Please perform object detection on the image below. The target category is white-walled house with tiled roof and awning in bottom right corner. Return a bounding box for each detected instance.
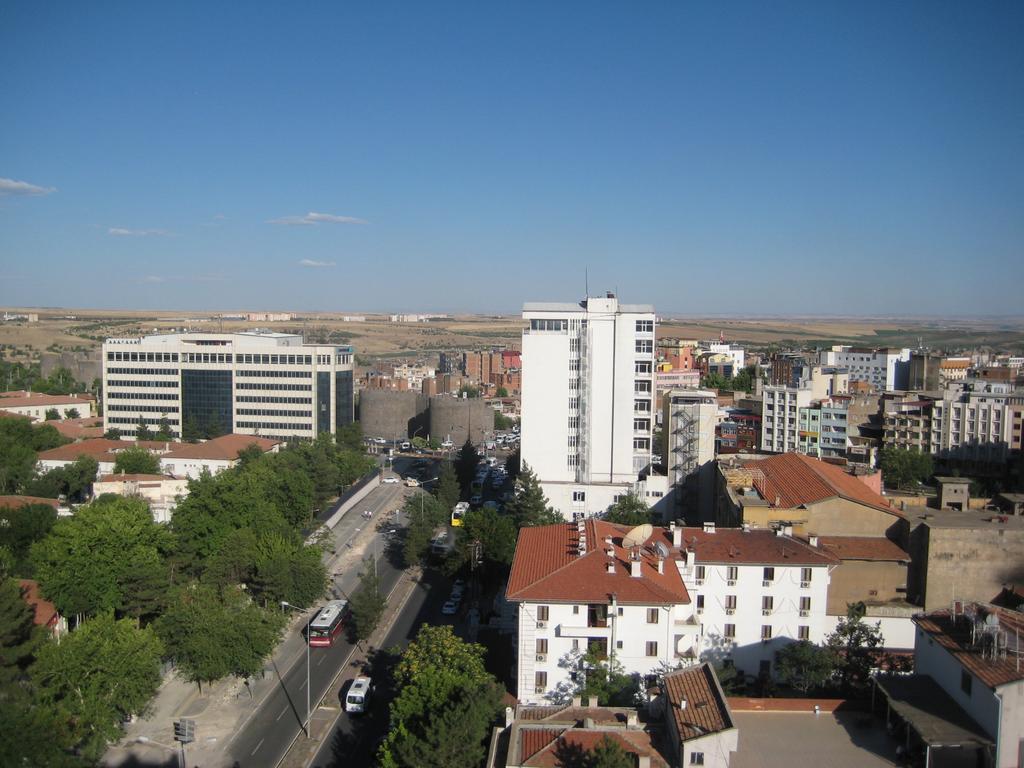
[877,601,1024,768]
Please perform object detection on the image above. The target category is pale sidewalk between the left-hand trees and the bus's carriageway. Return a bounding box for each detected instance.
[100,486,408,768]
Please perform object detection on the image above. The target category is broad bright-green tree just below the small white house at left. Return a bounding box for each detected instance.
[31,496,172,615]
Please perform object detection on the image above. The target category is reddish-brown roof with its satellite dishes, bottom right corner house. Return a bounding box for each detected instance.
[913,603,1024,688]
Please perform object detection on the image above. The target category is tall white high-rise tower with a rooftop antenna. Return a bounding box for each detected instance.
[521,294,655,519]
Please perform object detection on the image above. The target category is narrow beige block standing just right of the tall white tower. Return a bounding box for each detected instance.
[662,389,718,521]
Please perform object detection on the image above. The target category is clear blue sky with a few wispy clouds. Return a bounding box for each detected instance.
[0,0,1024,315]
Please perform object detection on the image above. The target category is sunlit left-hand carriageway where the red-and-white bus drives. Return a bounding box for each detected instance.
[227,485,402,766]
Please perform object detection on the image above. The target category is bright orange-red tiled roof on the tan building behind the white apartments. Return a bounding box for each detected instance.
[743,453,902,517]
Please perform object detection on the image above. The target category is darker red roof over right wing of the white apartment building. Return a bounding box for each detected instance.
[667,528,836,565]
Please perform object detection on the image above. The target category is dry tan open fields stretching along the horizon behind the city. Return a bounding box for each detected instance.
[0,307,1024,359]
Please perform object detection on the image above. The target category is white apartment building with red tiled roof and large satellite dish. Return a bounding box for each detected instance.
[506,519,839,703]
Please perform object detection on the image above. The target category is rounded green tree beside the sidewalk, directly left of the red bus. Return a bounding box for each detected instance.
[155,584,286,687]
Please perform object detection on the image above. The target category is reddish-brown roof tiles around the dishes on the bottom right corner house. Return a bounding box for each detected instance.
[913,603,1024,688]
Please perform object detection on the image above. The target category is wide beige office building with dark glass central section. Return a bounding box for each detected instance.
[103,333,353,439]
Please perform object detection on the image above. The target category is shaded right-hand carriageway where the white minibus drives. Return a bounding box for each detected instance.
[311,568,466,768]
